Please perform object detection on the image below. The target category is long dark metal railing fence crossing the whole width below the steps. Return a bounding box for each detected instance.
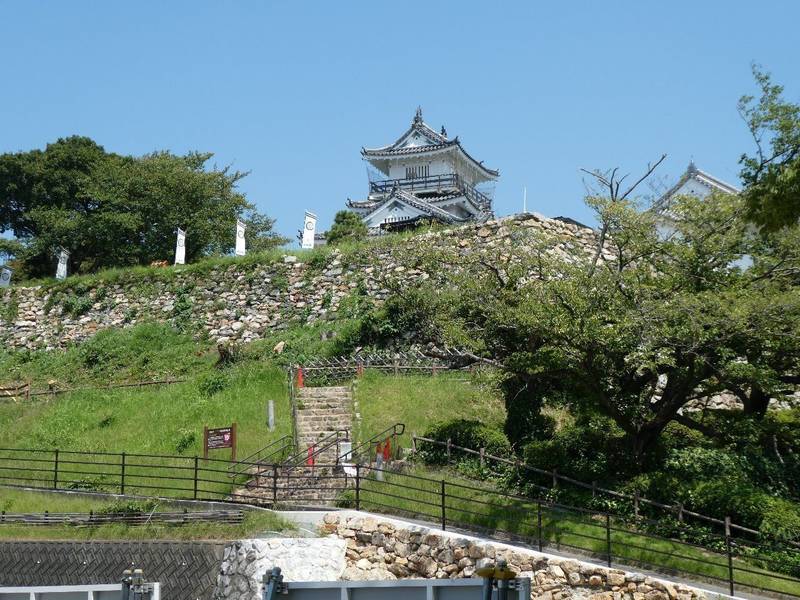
[0,448,800,598]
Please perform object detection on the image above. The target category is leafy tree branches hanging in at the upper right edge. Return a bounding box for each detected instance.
[739,66,800,231]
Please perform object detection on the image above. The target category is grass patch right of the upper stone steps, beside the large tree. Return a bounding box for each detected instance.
[355,370,505,443]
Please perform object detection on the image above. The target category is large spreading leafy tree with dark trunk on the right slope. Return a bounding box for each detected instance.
[382,196,800,468]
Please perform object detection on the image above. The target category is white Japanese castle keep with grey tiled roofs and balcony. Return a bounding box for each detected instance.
[347,108,500,235]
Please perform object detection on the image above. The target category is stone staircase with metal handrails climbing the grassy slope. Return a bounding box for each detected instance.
[230,386,352,506]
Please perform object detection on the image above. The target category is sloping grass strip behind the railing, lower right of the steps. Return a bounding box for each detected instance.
[351,468,800,594]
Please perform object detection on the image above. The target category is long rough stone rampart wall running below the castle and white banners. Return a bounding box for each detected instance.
[0,214,594,349]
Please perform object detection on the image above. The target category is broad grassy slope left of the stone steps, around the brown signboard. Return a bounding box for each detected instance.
[0,324,292,499]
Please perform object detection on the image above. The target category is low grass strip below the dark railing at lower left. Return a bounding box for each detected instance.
[0,488,294,540]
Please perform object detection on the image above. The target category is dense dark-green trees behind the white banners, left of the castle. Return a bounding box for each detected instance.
[0,136,285,276]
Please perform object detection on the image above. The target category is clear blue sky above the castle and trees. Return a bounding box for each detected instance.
[0,0,800,241]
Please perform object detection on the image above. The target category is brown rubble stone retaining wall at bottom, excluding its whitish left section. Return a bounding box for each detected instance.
[322,511,707,600]
